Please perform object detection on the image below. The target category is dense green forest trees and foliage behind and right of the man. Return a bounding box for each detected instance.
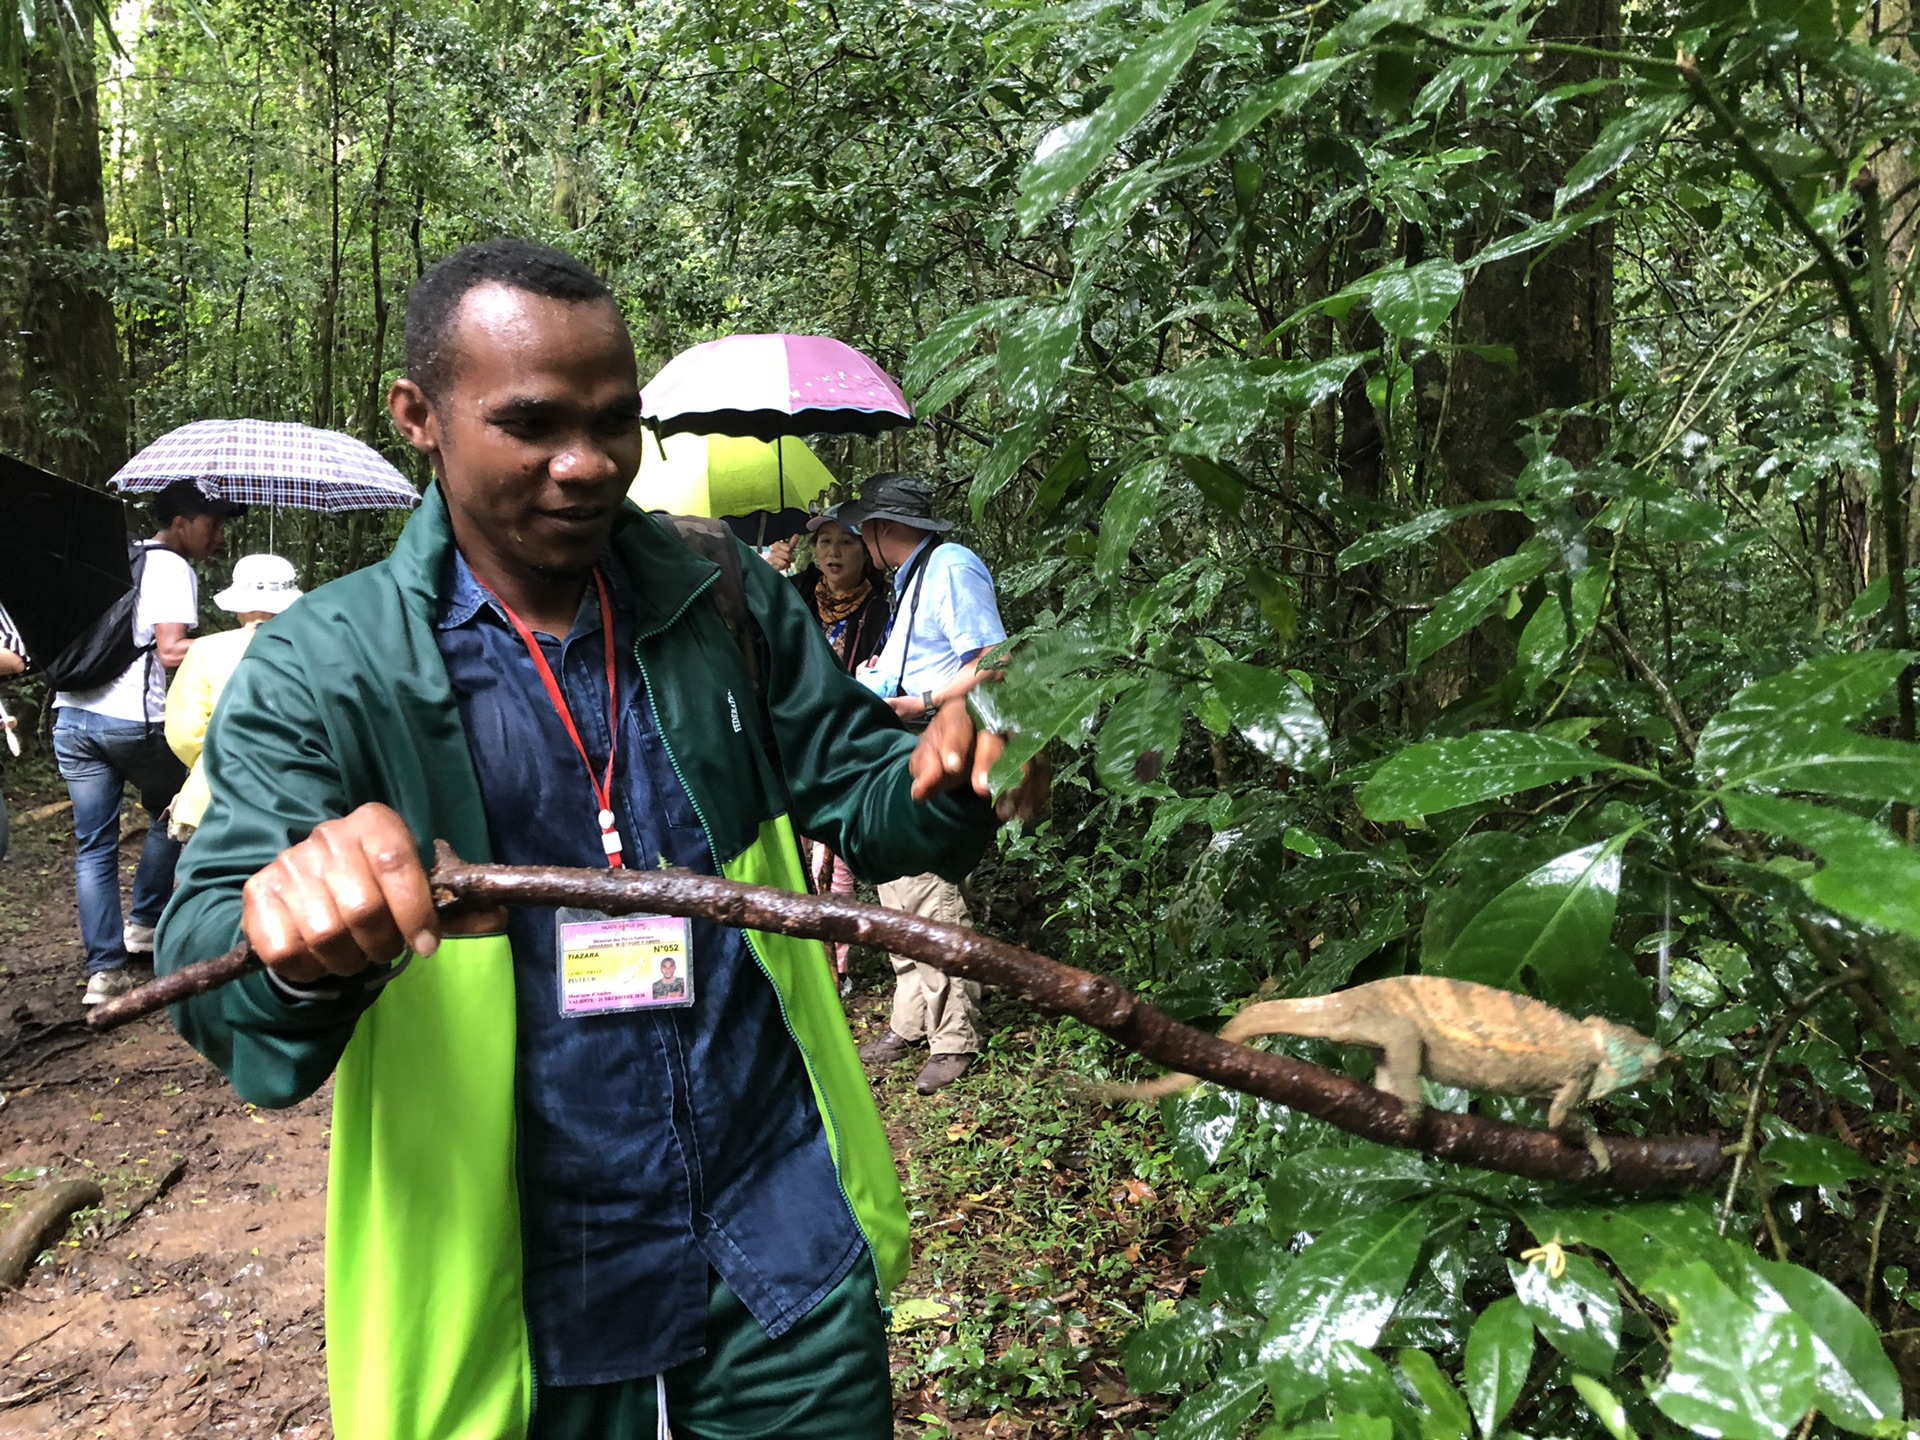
[0,0,1920,1440]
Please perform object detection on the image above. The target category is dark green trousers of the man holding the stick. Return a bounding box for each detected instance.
[530,1258,893,1440]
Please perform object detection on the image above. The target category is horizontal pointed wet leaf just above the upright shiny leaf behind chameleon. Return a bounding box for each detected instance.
[1359,730,1617,822]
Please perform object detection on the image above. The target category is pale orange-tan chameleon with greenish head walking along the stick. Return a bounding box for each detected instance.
[1104,975,1668,1169]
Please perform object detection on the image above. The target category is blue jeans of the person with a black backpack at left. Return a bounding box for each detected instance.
[54,705,186,975]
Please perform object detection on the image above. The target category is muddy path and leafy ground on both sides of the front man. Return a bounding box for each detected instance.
[0,762,1194,1440]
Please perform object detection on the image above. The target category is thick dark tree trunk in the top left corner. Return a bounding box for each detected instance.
[0,0,127,484]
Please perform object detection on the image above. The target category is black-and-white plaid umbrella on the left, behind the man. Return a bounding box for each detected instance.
[113,420,420,515]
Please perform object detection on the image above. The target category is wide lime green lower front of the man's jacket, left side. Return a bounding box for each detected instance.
[326,935,534,1440]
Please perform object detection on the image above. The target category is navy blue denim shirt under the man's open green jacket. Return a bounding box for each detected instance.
[436,555,866,1384]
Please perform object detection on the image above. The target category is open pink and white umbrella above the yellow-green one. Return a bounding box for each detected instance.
[641,334,914,440]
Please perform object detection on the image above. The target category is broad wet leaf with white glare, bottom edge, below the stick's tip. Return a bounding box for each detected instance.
[1645,1260,1818,1440]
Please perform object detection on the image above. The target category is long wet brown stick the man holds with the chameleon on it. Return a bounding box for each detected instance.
[88,843,1726,1190]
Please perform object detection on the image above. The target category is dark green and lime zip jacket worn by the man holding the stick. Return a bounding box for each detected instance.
[157,486,995,1440]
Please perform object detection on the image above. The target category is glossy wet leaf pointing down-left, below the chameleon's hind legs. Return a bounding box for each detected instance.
[1260,1204,1427,1388]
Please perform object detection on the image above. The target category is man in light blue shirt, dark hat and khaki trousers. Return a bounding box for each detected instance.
[843,472,1006,1094]
